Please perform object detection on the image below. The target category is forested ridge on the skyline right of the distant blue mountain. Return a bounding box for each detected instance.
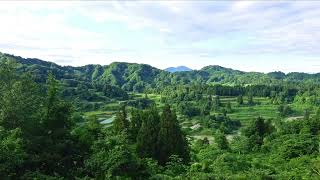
[175,66,320,85]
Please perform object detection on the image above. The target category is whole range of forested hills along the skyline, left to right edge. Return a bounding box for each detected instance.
[0,53,320,92]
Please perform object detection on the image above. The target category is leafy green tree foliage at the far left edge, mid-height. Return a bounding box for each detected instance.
[0,61,40,131]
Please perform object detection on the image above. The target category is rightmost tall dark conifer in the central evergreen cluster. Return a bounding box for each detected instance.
[157,105,189,164]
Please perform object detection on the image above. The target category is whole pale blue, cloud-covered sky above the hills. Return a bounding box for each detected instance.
[0,0,320,73]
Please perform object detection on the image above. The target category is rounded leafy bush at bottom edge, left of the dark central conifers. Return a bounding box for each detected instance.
[85,135,146,179]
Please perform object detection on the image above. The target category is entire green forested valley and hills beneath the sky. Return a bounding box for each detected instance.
[0,53,320,180]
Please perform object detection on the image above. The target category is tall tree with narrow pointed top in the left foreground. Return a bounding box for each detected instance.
[29,74,77,176]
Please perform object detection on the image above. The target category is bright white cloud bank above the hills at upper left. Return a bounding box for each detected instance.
[0,2,125,65]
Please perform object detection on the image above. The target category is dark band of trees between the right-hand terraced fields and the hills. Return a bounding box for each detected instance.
[159,84,298,102]
